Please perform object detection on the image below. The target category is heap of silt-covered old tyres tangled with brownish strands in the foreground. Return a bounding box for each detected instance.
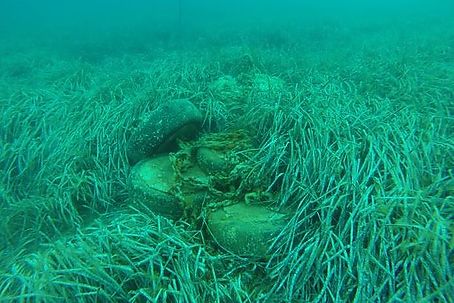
[129,100,287,258]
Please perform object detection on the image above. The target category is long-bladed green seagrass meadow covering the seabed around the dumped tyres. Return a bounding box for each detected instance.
[0,1,454,303]
